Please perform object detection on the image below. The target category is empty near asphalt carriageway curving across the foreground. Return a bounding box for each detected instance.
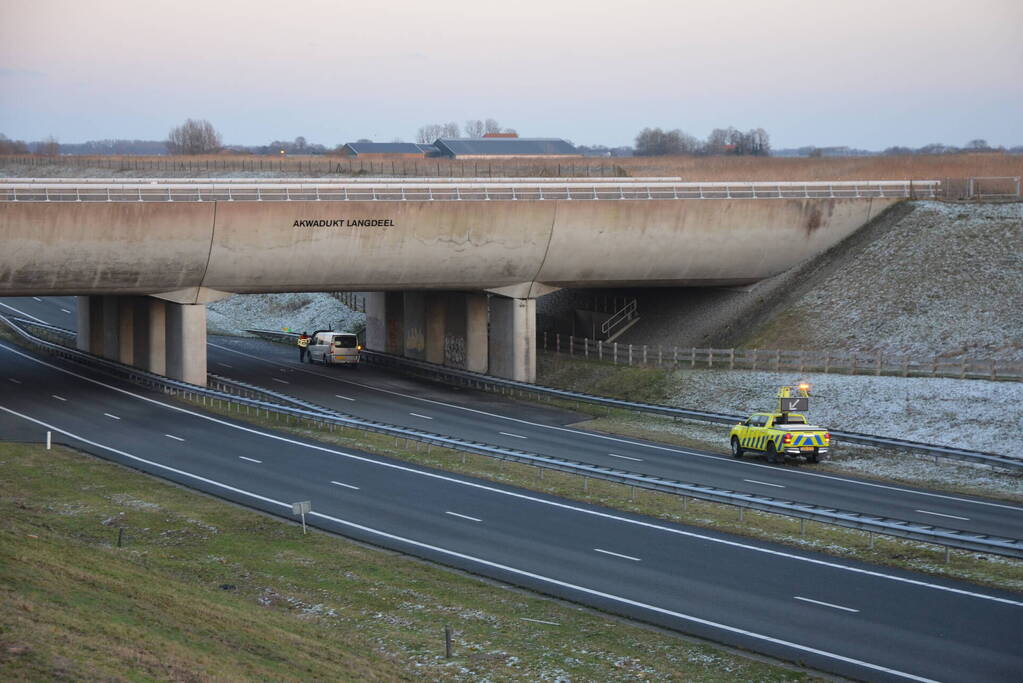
[0,342,1023,681]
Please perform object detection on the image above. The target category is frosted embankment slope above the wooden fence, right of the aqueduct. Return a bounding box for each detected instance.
[746,201,1023,360]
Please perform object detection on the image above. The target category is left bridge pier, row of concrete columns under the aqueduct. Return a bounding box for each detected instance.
[76,295,207,386]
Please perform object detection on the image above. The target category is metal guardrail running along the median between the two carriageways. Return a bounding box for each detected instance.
[0,315,1023,558]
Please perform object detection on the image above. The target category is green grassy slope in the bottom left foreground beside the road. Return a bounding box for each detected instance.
[0,444,807,681]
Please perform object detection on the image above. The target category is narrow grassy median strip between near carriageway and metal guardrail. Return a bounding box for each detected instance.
[175,394,1023,591]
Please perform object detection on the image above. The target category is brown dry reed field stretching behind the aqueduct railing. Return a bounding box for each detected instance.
[0,152,1023,181]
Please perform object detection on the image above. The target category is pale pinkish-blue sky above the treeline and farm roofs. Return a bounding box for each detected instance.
[0,0,1023,149]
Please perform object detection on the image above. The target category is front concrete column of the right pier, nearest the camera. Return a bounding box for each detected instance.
[490,297,536,381]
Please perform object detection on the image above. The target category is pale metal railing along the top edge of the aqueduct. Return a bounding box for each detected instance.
[0,180,941,202]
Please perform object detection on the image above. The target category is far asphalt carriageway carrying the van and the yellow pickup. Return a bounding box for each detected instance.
[6,298,1023,538]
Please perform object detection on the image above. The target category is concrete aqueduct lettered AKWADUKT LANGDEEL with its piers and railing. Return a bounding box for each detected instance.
[0,178,938,383]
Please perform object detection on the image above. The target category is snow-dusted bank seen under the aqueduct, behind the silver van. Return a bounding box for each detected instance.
[207,292,366,335]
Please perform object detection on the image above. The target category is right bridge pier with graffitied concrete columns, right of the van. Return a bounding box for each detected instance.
[366,291,536,381]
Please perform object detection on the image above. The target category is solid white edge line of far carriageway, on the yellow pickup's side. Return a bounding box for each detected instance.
[203,341,1023,512]
